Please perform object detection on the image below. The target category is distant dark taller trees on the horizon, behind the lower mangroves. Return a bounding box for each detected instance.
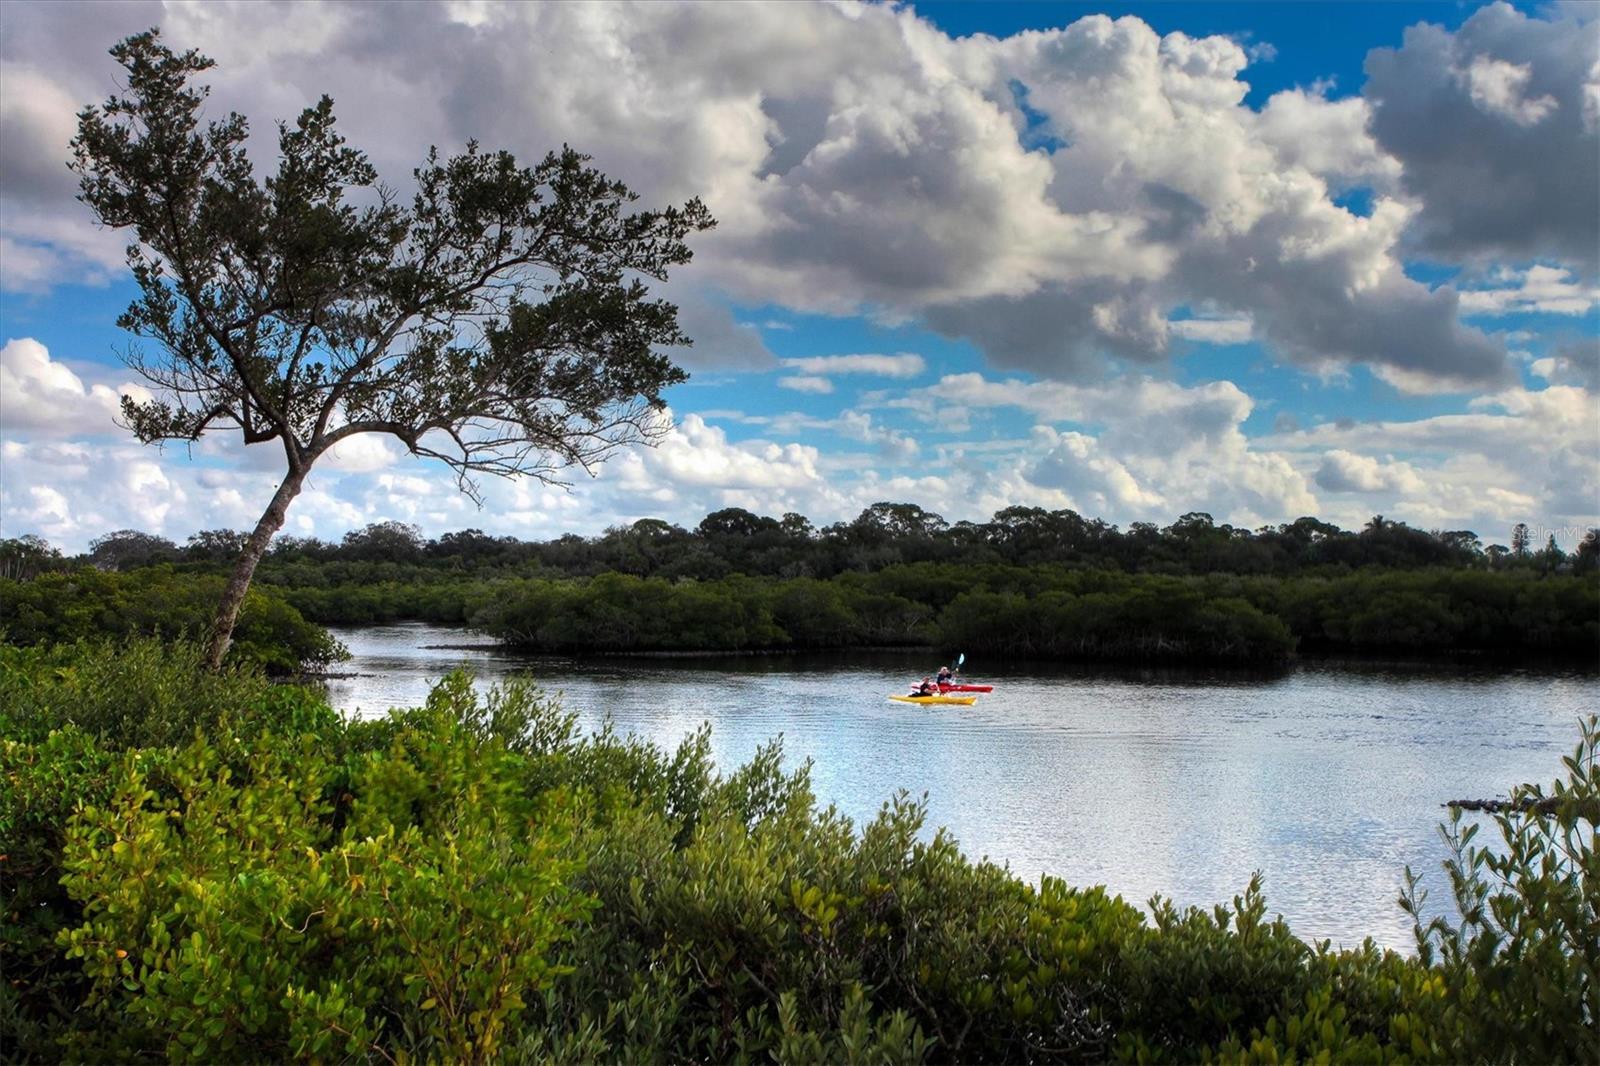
[0,503,1600,584]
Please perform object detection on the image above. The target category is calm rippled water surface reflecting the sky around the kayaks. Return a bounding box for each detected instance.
[318,626,1600,949]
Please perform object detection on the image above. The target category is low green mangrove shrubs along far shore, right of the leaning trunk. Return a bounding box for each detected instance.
[265,562,1600,663]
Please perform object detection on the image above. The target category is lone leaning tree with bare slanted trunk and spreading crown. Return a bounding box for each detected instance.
[70,30,714,667]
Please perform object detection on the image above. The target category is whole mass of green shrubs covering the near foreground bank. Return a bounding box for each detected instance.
[0,651,1600,1063]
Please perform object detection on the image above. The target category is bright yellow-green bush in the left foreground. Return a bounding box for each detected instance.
[59,701,589,1061]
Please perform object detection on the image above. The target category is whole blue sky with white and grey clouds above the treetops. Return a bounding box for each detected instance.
[0,0,1600,551]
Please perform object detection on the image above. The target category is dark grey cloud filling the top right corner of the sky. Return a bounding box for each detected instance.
[1363,3,1600,272]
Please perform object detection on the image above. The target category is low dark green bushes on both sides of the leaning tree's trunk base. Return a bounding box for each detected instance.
[0,567,347,674]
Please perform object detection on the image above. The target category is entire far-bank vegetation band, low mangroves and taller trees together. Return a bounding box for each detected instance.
[0,504,1600,671]
